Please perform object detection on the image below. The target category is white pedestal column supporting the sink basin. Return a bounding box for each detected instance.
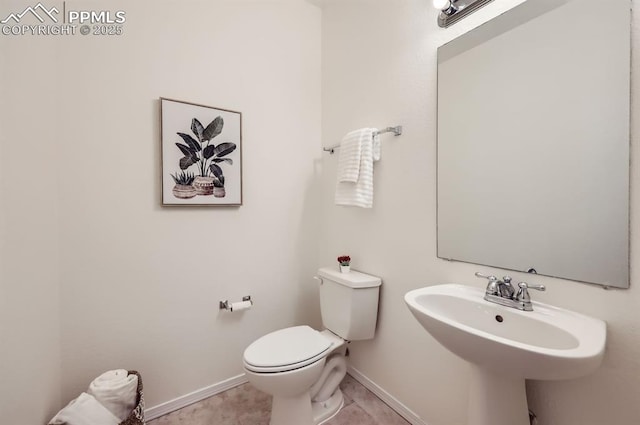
[467,363,529,425]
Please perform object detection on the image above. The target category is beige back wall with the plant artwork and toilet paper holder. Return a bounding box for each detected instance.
[55,1,321,406]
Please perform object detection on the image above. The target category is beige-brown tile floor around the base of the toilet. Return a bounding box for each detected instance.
[148,375,409,425]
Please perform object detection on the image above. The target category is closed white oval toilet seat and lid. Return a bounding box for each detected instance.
[244,326,332,373]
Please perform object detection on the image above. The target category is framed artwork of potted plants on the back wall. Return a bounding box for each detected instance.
[160,98,242,206]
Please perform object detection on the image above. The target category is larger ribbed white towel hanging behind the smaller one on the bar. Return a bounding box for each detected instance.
[335,128,380,208]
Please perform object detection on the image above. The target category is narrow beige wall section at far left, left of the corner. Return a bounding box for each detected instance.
[0,34,60,425]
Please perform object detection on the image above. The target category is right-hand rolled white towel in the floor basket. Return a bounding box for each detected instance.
[88,369,138,421]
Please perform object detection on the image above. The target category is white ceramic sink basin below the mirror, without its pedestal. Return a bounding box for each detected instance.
[405,284,606,379]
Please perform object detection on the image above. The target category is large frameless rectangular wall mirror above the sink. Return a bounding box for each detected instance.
[438,0,631,288]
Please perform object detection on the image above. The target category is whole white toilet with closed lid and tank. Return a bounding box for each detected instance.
[243,267,382,425]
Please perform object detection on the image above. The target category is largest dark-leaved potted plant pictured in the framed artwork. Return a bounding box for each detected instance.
[176,116,236,198]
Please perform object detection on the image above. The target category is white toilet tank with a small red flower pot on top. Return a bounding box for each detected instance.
[318,267,382,341]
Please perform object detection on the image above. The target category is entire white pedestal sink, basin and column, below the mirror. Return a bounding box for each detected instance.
[404,284,607,425]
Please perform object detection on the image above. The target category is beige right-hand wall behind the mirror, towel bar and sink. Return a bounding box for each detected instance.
[320,0,640,425]
